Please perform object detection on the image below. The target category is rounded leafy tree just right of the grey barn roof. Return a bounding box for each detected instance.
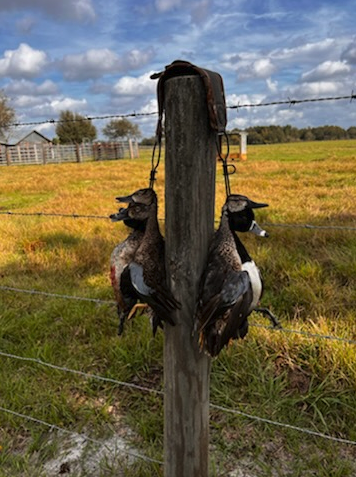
[56,110,96,144]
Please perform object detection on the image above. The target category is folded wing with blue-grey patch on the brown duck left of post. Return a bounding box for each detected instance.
[129,262,180,325]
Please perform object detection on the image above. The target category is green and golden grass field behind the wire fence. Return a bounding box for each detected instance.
[0,141,356,477]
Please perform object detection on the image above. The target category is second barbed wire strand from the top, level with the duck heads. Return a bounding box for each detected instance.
[0,210,356,231]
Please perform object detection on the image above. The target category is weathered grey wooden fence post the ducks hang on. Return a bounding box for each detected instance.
[164,76,216,477]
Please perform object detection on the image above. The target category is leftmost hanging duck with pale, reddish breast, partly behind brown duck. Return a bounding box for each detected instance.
[110,207,146,336]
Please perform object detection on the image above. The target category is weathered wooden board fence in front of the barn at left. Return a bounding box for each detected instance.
[0,140,139,166]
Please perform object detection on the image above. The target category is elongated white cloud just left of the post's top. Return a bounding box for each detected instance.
[59,48,154,81]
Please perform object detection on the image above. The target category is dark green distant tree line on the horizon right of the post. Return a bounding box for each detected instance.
[229,124,356,144]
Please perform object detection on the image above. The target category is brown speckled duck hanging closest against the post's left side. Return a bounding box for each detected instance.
[117,189,180,334]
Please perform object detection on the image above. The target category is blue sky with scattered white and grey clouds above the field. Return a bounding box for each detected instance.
[0,0,356,137]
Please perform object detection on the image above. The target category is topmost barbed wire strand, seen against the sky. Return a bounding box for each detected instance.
[11,91,356,127]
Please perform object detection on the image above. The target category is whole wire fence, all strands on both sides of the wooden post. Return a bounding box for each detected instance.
[0,91,356,472]
